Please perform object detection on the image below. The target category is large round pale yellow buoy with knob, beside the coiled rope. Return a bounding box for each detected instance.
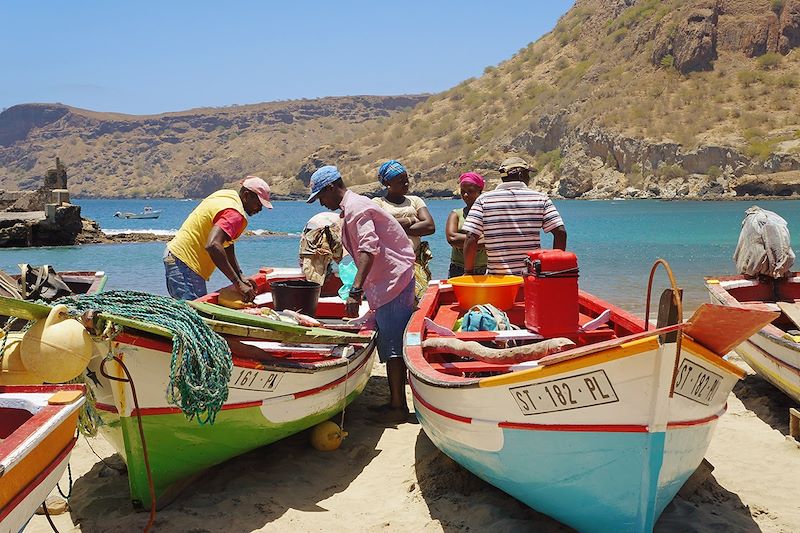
[20,305,93,383]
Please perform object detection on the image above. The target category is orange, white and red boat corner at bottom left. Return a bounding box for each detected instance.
[0,384,85,532]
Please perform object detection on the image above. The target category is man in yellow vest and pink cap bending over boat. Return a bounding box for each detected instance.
[164,176,272,301]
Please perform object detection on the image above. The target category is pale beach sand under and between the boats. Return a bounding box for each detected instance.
[26,355,800,533]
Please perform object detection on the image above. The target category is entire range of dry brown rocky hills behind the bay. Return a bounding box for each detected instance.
[0,0,800,198]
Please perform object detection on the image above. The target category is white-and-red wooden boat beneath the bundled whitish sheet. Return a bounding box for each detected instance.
[705,272,800,402]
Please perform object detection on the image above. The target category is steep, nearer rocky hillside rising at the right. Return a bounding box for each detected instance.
[315,0,800,198]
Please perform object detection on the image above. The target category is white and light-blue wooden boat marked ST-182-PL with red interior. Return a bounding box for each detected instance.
[404,255,774,531]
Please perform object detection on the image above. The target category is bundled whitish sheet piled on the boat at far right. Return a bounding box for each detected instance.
[733,206,794,278]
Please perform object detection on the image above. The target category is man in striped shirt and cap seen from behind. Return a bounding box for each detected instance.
[463,157,567,275]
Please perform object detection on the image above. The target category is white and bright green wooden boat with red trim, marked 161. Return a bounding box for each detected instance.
[0,269,375,508]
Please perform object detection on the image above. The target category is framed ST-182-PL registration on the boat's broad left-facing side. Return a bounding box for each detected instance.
[509,370,619,416]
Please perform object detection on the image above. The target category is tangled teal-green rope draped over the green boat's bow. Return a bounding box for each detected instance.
[54,291,233,425]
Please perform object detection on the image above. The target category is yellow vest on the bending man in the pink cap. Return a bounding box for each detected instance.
[167,189,247,280]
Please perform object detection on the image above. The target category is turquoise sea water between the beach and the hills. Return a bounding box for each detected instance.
[0,200,800,313]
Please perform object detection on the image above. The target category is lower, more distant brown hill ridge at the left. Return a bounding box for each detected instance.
[0,95,426,197]
